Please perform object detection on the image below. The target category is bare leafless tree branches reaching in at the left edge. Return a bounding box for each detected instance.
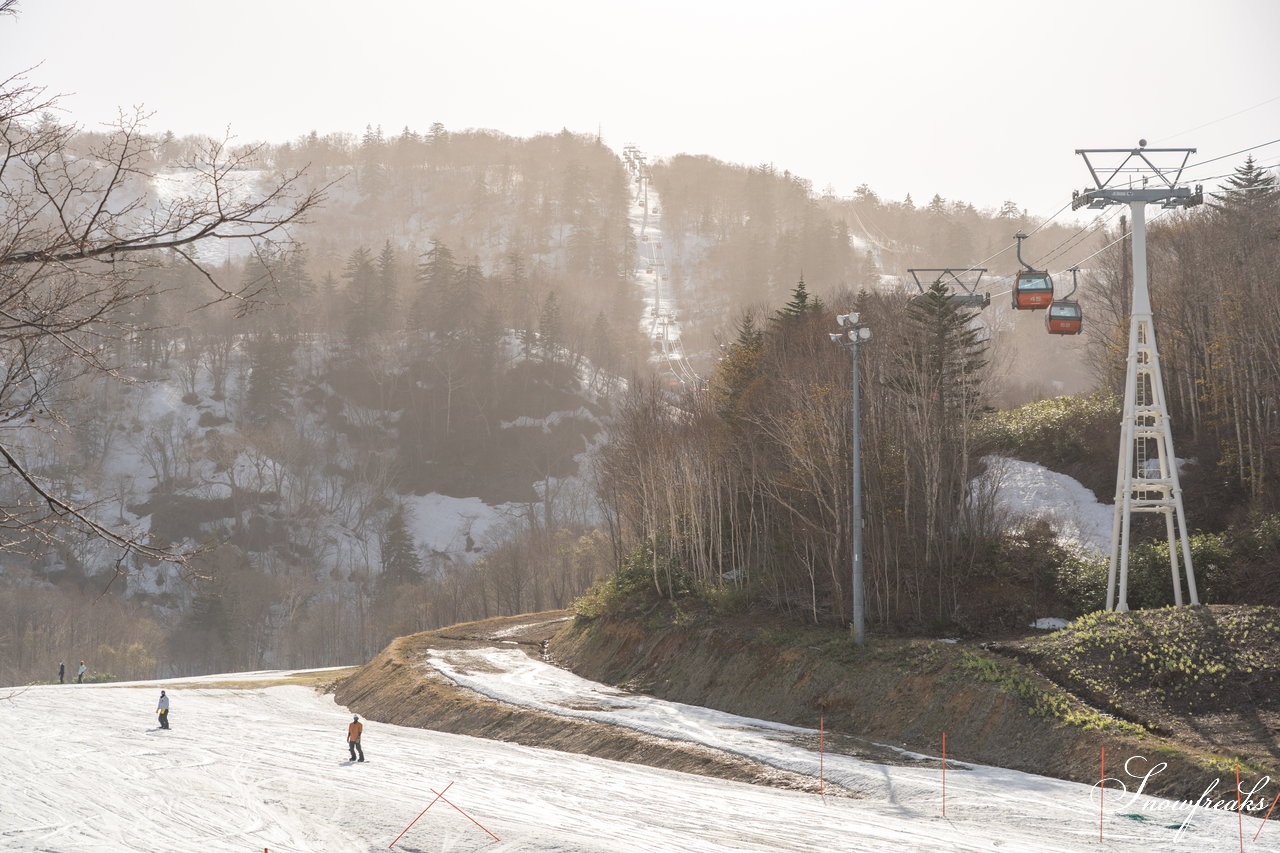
[0,61,324,566]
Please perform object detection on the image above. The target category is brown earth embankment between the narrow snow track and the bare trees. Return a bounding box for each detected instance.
[556,604,1280,798]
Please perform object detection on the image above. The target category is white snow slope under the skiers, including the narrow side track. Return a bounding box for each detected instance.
[0,649,1280,853]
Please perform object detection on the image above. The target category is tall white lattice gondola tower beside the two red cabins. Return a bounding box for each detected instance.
[1071,140,1204,611]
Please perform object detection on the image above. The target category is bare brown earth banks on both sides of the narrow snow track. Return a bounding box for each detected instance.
[335,604,1277,798]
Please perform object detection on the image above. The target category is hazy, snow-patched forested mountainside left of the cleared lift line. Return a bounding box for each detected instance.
[4,124,639,676]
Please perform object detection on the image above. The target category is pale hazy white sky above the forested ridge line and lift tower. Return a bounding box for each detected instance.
[0,0,1280,214]
